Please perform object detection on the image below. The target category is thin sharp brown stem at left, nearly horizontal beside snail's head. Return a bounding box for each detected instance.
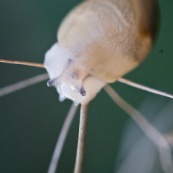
[0,59,45,68]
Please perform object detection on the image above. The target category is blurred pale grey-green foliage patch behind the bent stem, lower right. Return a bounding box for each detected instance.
[115,97,173,173]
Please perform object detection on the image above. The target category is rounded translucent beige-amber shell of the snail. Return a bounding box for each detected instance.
[58,0,157,82]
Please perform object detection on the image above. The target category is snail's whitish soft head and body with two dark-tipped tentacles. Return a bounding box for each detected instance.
[44,43,105,104]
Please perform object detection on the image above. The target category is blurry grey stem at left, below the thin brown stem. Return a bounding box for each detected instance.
[0,73,48,97]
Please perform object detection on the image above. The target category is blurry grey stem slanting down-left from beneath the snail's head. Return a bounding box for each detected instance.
[48,103,77,173]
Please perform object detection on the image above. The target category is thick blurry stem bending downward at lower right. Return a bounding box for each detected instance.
[104,85,173,173]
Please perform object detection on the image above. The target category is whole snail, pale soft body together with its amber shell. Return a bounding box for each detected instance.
[44,0,156,104]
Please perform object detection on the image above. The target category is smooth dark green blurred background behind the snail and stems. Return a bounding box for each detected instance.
[0,0,173,173]
